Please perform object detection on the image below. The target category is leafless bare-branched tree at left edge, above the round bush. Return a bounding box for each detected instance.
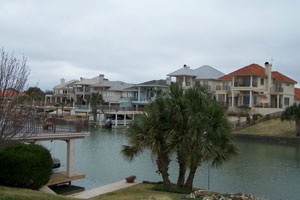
[0,48,35,150]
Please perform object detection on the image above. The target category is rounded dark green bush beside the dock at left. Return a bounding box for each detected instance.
[0,143,53,189]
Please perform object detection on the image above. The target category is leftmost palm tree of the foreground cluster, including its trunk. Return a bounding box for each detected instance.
[122,94,171,185]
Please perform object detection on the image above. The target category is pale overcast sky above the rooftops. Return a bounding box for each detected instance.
[0,0,300,89]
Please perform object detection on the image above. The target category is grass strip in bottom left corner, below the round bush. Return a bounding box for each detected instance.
[0,186,71,200]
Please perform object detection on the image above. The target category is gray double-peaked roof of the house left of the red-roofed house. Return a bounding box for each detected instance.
[167,65,225,79]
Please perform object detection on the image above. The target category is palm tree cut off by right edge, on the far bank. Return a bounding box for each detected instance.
[281,104,300,136]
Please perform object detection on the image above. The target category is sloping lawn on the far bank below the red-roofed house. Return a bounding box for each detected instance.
[234,119,297,137]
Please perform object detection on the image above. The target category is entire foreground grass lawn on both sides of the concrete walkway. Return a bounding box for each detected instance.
[0,184,185,200]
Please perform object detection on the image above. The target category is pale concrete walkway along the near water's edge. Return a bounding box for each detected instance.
[69,180,139,199]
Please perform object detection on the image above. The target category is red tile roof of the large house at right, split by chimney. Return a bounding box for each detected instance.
[219,64,297,84]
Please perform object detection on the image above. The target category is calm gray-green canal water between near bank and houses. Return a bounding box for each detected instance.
[43,129,300,200]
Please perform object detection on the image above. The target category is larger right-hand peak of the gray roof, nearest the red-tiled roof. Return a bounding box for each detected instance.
[194,65,225,79]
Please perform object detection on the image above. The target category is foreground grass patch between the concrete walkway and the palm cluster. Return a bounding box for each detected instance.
[92,183,185,200]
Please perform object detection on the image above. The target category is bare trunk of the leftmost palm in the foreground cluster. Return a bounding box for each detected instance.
[156,154,171,185]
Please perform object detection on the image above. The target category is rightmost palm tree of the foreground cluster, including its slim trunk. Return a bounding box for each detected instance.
[185,87,237,189]
